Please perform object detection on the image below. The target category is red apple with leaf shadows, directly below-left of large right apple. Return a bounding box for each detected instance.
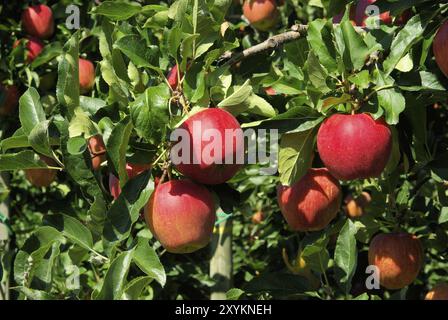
[277,168,342,232]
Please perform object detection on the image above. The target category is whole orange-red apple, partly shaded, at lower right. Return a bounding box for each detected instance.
[369,233,423,290]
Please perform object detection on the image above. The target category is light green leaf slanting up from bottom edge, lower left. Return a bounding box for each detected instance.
[93,250,133,300]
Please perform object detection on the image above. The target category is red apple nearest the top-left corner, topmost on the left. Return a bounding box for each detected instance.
[22,4,54,39]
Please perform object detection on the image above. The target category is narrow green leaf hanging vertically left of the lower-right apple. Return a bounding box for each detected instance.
[334,219,358,294]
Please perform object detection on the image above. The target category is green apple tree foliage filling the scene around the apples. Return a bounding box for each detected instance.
[0,0,448,299]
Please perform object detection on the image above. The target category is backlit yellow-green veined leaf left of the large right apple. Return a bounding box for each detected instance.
[278,129,316,186]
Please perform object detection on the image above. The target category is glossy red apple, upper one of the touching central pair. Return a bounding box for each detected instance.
[171,108,244,184]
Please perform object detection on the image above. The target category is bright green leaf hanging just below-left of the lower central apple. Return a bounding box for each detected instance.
[133,238,166,287]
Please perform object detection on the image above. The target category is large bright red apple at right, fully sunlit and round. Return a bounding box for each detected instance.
[317,113,392,180]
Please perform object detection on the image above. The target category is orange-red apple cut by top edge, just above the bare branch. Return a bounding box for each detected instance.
[243,0,280,31]
